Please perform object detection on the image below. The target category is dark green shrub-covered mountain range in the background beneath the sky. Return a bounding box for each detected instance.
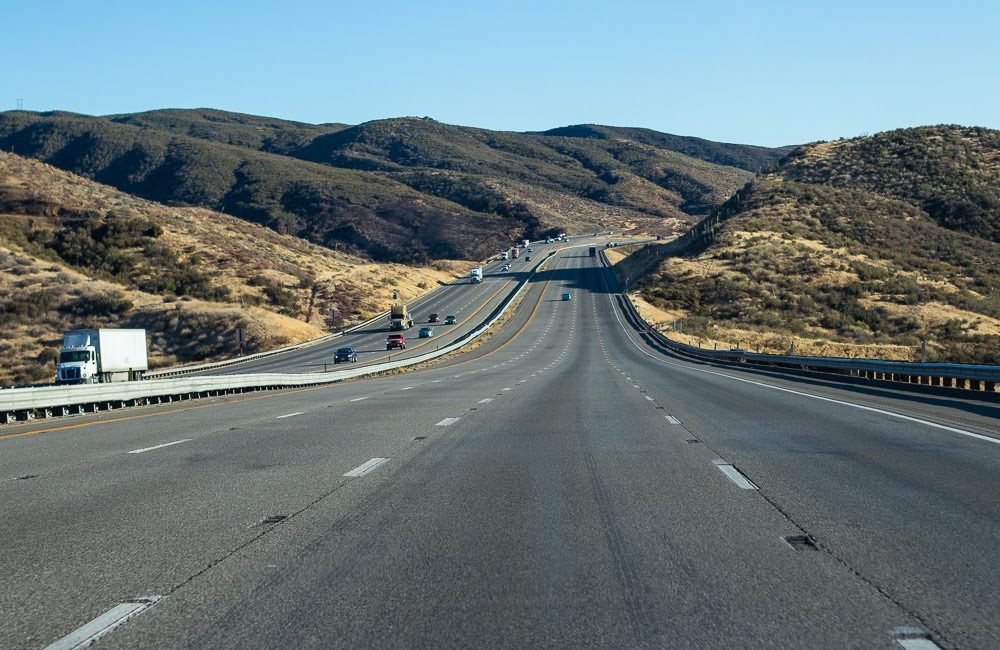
[0,109,781,263]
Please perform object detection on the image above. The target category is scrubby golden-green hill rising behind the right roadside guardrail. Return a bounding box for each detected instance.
[623,126,1000,363]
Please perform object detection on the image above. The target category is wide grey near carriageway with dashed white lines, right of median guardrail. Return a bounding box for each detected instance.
[0,248,1000,649]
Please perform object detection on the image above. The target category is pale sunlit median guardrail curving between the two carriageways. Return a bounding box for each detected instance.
[0,251,555,424]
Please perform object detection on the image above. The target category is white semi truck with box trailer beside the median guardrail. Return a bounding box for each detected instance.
[56,329,149,384]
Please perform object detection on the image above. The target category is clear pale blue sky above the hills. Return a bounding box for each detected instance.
[7,0,1000,145]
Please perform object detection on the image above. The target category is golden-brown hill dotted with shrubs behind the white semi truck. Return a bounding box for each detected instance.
[0,152,457,384]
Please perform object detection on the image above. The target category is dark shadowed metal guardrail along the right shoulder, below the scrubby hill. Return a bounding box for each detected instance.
[601,251,1000,393]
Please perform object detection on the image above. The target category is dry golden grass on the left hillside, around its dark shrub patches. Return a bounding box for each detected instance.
[0,152,472,384]
